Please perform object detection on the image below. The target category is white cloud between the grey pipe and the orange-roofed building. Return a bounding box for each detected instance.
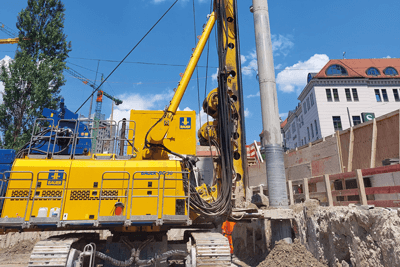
[276,54,329,93]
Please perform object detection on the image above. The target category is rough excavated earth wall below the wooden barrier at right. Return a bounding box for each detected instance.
[293,205,400,267]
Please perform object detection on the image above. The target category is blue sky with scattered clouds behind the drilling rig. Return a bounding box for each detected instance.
[0,0,400,143]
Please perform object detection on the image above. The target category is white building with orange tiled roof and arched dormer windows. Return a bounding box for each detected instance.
[282,58,400,149]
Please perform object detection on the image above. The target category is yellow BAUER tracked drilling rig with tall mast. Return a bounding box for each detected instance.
[0,0,247,267]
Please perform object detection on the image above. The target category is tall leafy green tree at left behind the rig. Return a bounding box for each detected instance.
[0,0,71,150]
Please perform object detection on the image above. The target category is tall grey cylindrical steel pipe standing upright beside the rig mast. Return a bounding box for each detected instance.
[250,0,292,243]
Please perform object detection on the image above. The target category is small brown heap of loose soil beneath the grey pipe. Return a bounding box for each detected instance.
[258,239,327,267]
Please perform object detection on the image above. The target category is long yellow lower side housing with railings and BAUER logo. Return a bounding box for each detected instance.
[2,158,187,223]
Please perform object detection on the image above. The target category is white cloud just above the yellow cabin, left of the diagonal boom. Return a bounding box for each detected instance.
[113,90,174,122]
